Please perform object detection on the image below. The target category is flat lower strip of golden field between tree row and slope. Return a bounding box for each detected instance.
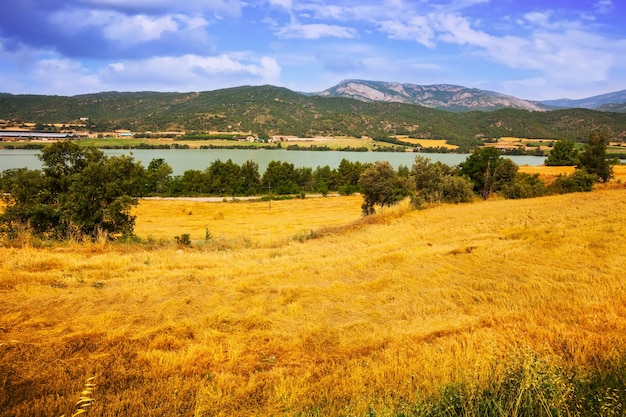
[133,196,363,246]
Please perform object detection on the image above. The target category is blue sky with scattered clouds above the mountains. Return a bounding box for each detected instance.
[0,0,626,100]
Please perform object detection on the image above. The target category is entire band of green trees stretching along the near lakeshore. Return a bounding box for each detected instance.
[0,134,612,239]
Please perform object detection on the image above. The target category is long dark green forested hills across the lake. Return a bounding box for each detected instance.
[0,86,626,147]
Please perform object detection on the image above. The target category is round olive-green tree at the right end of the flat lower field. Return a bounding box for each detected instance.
[359,161,412,216]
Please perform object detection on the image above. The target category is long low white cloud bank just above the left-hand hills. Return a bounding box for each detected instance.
[0,51,282,95]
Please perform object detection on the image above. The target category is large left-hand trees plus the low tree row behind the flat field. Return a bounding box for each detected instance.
[0,141,365,240]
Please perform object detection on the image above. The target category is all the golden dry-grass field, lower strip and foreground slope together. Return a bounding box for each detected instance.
[0,188,626,416]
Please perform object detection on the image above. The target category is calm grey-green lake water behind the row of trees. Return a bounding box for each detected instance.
[0,149,545,175]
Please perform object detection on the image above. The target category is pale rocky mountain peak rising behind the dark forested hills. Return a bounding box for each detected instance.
[318,80,550,112]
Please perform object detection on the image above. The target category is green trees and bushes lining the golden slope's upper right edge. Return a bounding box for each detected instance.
[358,134,613,215]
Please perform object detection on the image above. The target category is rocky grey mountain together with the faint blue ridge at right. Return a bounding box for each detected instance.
[314,80,626,112]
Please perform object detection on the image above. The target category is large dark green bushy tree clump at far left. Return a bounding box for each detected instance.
[0,142,145,239]
